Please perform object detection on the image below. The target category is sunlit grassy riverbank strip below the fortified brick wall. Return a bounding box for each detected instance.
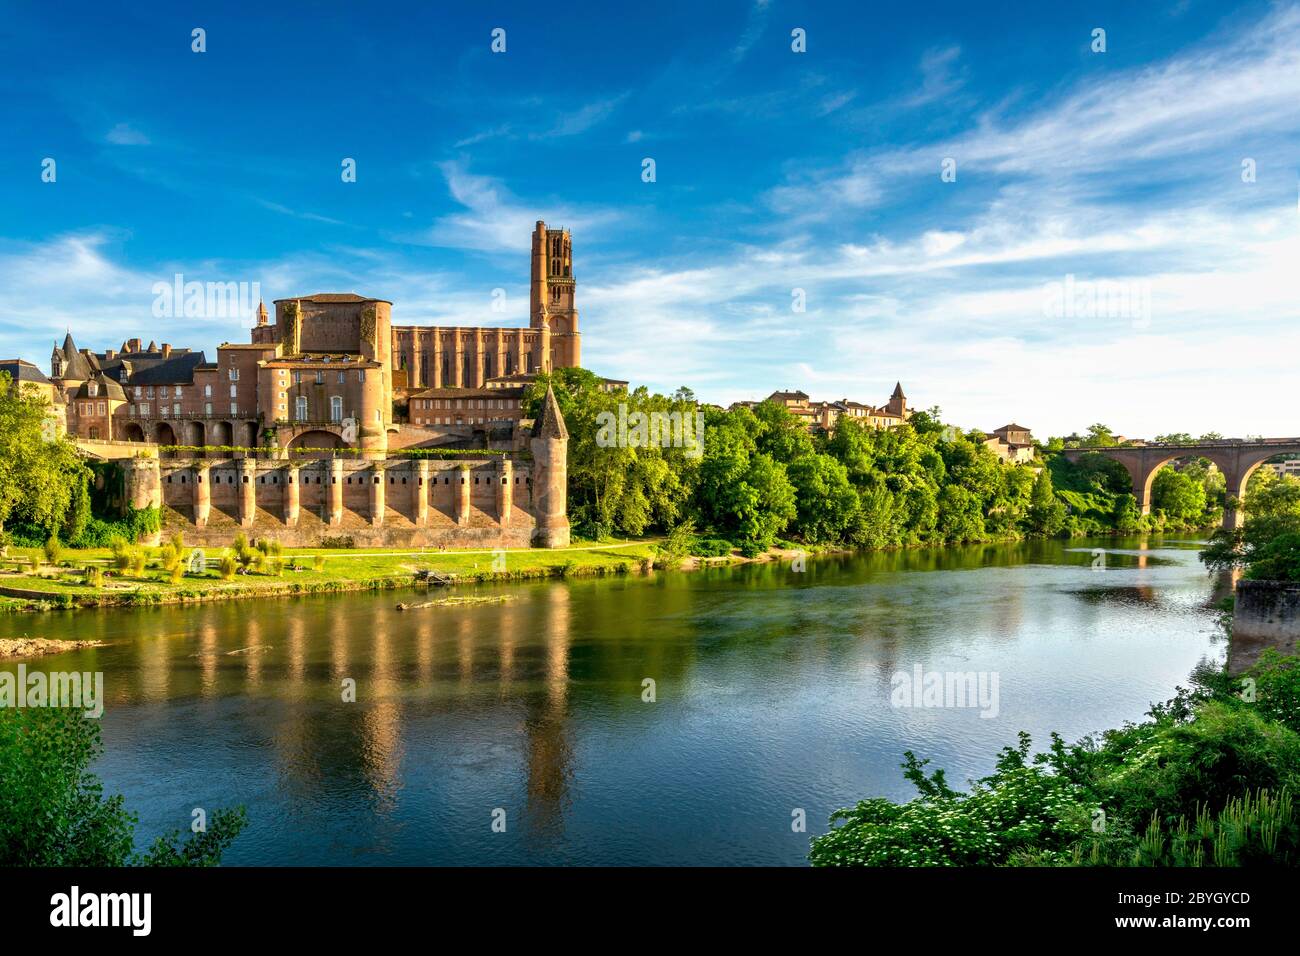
[0,540,657,611]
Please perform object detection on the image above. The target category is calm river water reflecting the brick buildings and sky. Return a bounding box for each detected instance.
[0,538,1226,865]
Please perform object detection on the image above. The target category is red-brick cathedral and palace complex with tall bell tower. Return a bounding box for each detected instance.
[45,221,585,455]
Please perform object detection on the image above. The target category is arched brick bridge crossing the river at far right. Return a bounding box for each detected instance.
[1063,438,1300,528]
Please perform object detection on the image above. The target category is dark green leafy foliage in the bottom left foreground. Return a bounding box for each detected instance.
[0,708,248,866]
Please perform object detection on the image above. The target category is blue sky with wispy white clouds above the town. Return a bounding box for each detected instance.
[0,0,1300,437]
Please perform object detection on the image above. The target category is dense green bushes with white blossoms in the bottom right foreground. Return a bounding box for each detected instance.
[809,653,1300,866]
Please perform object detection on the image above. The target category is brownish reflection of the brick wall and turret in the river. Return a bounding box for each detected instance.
[137,587,573,838]
